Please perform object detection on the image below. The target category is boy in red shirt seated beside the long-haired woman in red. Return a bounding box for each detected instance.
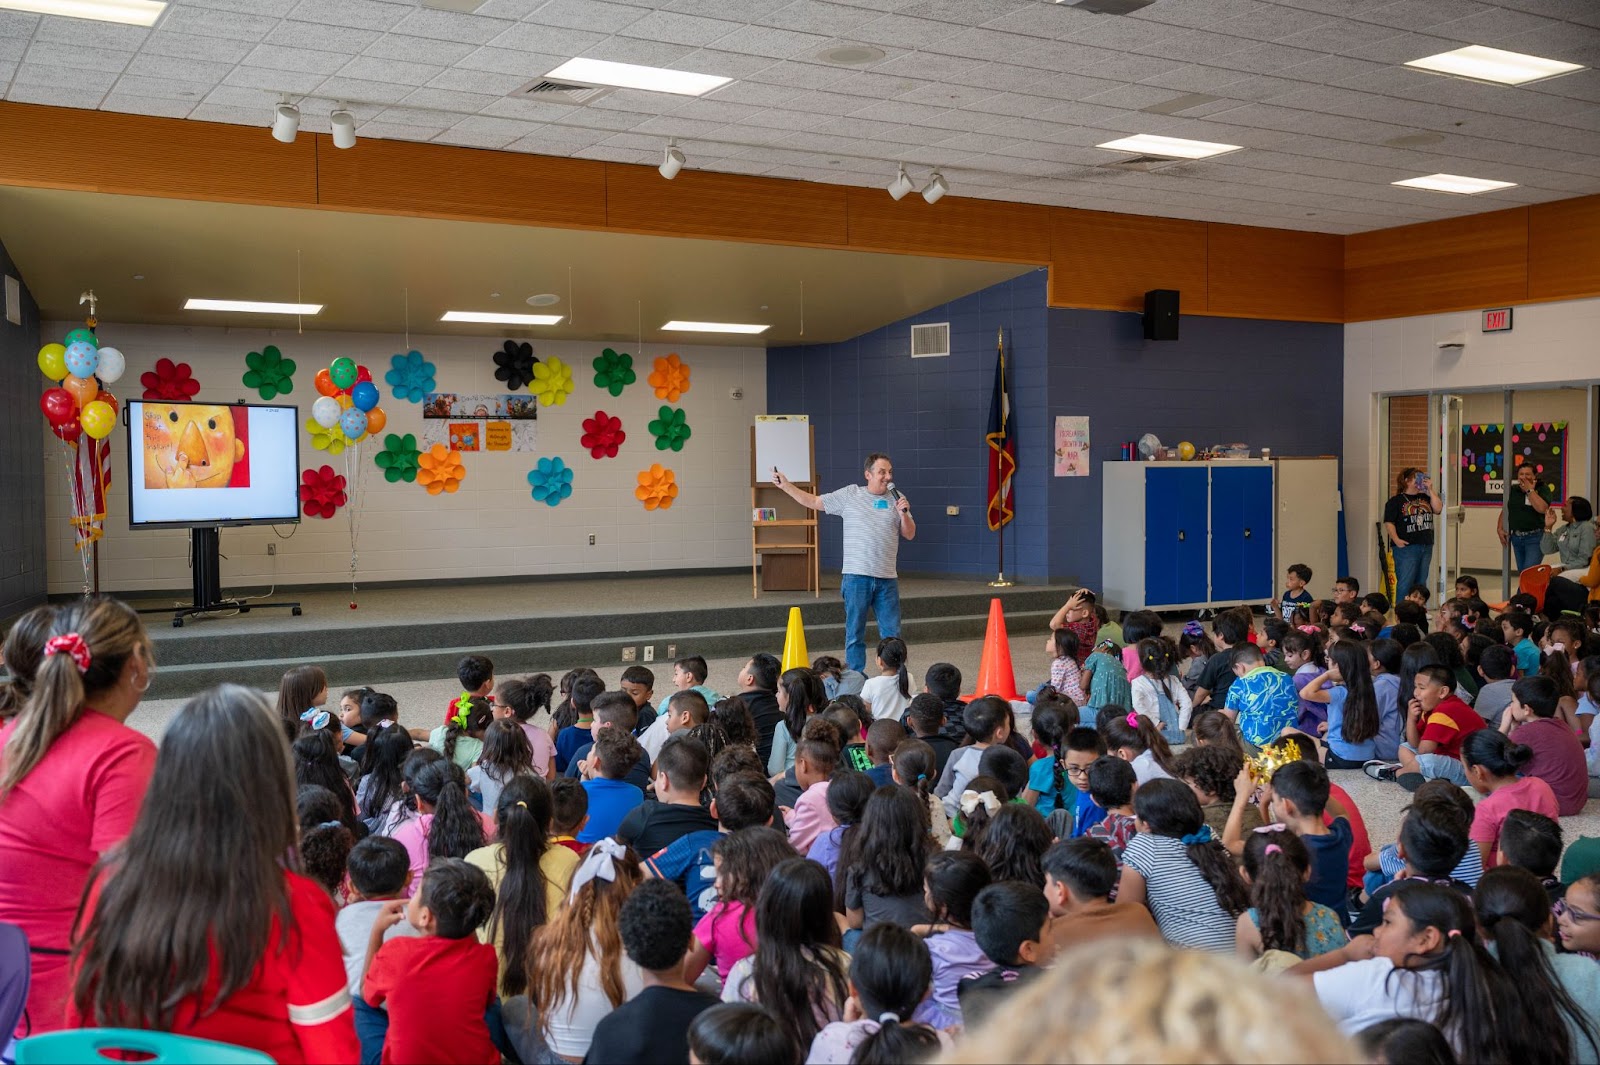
[362,859,501,1065]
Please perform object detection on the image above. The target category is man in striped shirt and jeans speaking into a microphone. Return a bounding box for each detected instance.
[773,451,917,672]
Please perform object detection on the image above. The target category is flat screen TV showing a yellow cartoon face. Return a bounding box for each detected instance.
[128,400,299,529]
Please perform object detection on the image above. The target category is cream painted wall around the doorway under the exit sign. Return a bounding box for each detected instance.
[1344,299,1600,584]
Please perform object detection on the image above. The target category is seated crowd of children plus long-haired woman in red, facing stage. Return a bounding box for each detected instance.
[9,566,1600,1065]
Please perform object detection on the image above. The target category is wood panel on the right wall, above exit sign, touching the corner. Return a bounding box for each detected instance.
[1344,208,1528,321]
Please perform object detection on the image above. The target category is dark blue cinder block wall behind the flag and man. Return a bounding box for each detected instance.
[766,270,1344,587]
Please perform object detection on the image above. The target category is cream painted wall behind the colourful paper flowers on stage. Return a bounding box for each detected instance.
[40,323,766,593]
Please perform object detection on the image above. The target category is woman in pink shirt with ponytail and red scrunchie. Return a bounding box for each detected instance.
[0,596,155,1033]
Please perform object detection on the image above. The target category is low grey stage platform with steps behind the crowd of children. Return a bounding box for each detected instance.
[128,572,1072,699]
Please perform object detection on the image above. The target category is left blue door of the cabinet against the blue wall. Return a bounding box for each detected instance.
[1144,467,1210,606]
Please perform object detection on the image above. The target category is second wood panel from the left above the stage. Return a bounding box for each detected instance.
[315,131,606,229]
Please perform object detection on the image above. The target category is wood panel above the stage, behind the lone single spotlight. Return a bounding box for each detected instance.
[606,163,850,248]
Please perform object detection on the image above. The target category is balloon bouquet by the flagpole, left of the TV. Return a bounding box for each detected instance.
[38,307,128,592]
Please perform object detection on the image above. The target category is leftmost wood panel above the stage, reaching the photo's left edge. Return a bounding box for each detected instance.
[0,102,317,206]
